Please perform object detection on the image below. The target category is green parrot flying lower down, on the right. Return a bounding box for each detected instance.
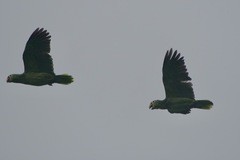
[149,49,213,114]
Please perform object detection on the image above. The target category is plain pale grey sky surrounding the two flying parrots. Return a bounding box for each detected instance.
[0,0,240,160]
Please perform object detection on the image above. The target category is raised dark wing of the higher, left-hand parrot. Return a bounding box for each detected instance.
[23,28,54,74]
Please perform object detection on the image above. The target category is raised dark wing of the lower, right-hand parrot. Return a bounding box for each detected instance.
[162,49,194,99]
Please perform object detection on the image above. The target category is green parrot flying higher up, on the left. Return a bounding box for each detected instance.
[7,28,73,86]
